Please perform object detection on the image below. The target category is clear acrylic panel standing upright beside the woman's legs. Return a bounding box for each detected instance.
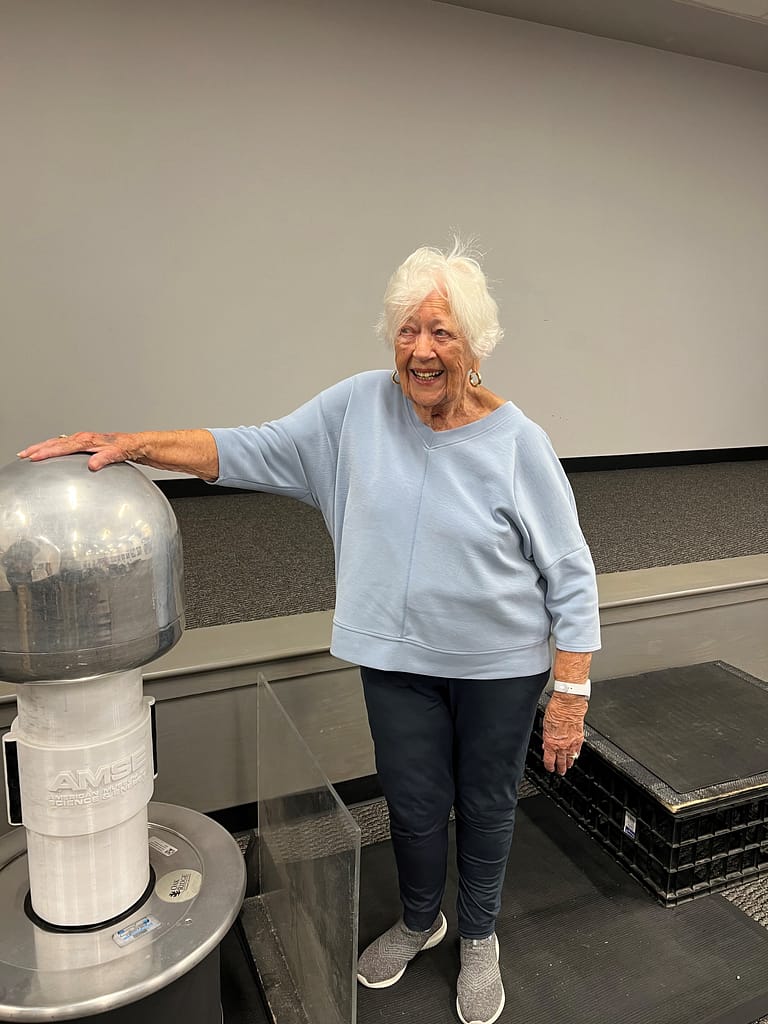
[257,676,360,1024]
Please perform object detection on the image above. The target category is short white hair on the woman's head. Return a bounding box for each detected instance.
[376,239,504,359]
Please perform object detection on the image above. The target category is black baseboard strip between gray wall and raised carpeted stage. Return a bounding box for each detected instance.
[155,444,768,498]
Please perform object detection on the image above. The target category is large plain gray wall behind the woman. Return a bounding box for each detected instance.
[0,0,768,463]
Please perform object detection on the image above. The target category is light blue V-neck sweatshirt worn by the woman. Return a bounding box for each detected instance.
[211,371,600,679]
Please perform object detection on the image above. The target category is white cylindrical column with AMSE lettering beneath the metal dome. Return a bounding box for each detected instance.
[6,669,153,928]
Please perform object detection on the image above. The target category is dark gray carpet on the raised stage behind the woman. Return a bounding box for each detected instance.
[171,460,768,629]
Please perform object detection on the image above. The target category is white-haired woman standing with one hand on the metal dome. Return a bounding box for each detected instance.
[19,246,599,1024]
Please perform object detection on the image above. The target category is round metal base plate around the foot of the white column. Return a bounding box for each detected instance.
[0,804,246,1021]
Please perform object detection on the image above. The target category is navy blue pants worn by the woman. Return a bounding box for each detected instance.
[360,668,549,939]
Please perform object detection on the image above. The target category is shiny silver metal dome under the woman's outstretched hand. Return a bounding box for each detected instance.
[0,455,183,683]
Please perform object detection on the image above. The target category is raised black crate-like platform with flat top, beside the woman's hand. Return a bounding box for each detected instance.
[527,662,768,906]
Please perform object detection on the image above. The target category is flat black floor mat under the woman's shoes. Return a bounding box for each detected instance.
[357,797,768,1024]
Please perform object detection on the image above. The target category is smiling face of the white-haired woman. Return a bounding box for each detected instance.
[394,292,477,422]
